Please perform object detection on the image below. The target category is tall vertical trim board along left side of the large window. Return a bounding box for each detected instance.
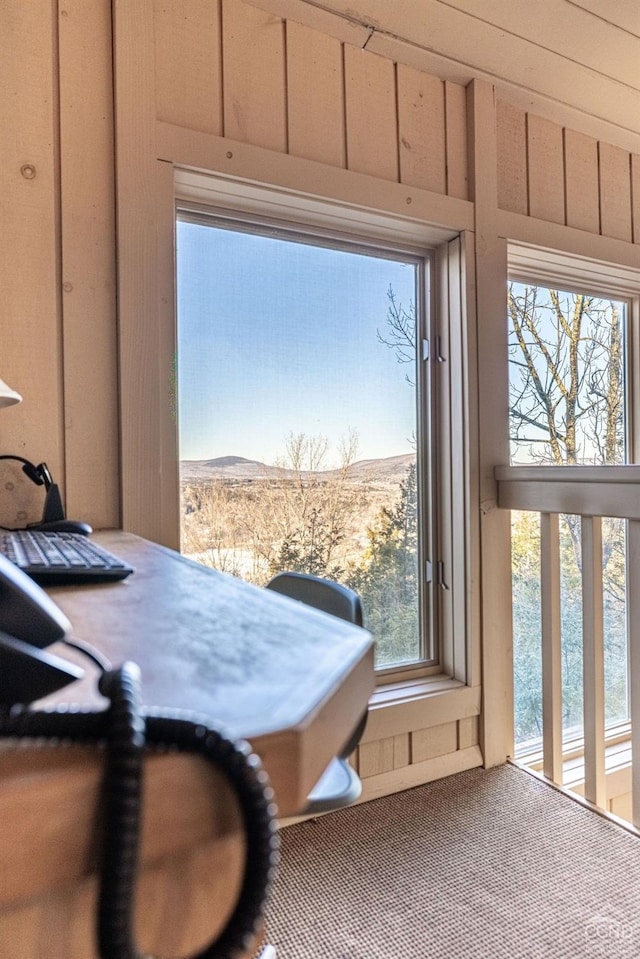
[114,0,178,546]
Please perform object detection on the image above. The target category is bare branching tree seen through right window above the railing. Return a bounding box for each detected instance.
[507,283,624,465]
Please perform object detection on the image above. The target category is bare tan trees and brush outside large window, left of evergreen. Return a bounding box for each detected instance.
[181,431,368,585]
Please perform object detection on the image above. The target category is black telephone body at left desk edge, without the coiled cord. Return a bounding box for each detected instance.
[0,555,83,706]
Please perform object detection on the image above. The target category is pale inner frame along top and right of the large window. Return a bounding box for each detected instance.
[174,168,473,695]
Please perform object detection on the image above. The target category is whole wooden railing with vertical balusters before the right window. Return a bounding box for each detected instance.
[495,466,640,828]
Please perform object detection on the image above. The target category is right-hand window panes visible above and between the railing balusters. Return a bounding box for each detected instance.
[507,280,630,751]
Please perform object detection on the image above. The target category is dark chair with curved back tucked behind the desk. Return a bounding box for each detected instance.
[267,573,367,815]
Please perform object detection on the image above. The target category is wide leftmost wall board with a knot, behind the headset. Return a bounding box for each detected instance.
[0,0,63,510]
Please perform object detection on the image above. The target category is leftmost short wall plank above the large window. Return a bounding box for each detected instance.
[154,0,222,135]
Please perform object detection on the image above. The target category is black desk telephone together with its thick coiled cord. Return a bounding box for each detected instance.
[0,555,278,959]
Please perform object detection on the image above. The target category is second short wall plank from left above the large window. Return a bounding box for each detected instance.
[222,0,287,153]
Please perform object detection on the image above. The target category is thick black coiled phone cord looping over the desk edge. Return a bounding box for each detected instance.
[0,663,278,959]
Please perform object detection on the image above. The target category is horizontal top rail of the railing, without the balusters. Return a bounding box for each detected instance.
[494,465,640,520]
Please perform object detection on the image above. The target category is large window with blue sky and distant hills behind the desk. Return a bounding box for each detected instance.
[177,211,438,671]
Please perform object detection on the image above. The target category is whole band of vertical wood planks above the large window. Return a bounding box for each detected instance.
[154,0,468,199]
